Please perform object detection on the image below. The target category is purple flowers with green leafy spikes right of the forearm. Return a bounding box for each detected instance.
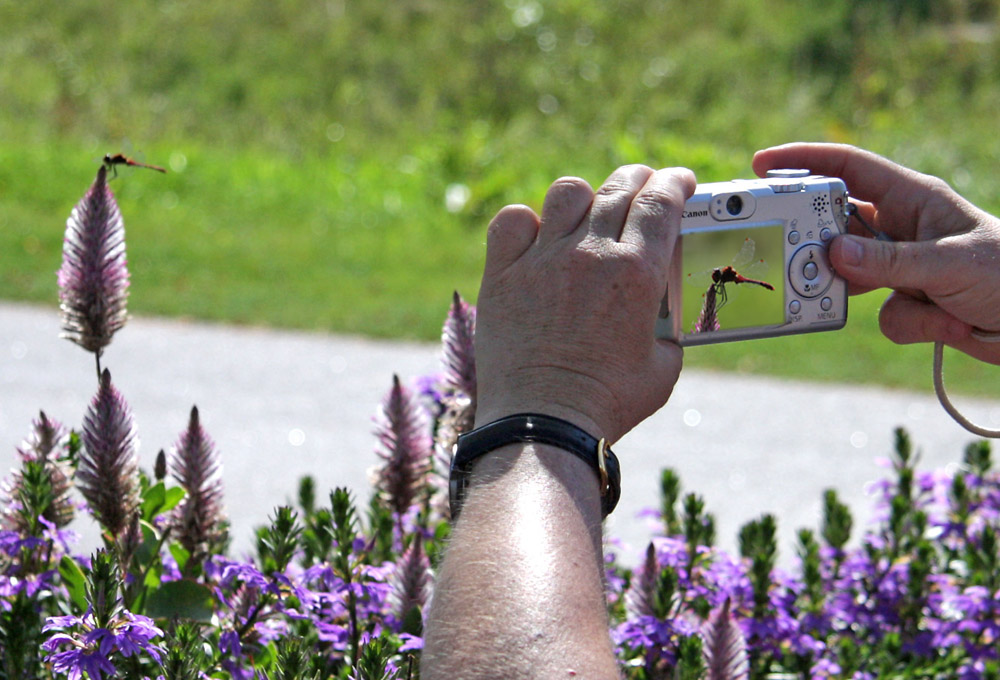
[600,430,1000,680]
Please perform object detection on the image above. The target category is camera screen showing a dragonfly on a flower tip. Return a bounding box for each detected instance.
[681,224,785,335]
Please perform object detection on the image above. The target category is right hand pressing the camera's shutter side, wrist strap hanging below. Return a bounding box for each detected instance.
[753,144,1000,364]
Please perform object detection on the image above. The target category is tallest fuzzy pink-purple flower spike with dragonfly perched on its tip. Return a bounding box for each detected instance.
[58,165,129,356]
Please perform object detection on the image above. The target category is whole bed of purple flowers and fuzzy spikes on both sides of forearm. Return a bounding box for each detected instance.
[0,161,1000,680]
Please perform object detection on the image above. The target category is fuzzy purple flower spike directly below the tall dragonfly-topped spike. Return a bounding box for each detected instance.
[76,369,139,536]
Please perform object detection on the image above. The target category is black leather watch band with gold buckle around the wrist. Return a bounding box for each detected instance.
[448,413,621,521]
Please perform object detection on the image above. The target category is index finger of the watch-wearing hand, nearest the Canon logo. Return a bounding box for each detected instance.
[621,168,697,258]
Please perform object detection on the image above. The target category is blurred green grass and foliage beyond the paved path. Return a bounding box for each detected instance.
[0,0,1000,396]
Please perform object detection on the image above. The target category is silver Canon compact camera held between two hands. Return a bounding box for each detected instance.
[656,170,848,345]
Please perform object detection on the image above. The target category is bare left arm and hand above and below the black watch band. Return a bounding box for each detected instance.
[421,166,695,680]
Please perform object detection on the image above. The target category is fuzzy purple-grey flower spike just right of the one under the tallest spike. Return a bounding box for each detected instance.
[170,407,225,563]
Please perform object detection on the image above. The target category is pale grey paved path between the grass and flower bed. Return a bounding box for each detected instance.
[0,304,1000,561]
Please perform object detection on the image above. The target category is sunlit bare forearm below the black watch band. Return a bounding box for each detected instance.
[421,444,618,680]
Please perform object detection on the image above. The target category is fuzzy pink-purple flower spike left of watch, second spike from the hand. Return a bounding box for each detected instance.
[375,375,431,516]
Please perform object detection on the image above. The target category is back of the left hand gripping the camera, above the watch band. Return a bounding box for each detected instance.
[476,165,695,442]
